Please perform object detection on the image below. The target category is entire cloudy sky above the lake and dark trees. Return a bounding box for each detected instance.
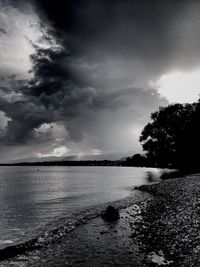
[0,0,200,162]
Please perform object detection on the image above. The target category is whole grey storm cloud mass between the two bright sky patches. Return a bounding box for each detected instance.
[0,0,200,161]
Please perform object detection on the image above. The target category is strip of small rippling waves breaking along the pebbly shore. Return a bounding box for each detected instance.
[0,191,151,266]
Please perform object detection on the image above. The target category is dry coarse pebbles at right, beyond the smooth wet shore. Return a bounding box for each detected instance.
[138,175,200,267]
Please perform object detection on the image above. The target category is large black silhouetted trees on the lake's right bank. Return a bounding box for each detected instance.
[140,101,200,170]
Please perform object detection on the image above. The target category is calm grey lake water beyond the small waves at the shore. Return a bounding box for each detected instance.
[0,166,161,248]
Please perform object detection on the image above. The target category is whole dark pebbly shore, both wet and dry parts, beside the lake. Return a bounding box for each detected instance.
[1,175,200,267]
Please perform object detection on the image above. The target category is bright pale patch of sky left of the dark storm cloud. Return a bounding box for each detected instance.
[0,3,42,79]
